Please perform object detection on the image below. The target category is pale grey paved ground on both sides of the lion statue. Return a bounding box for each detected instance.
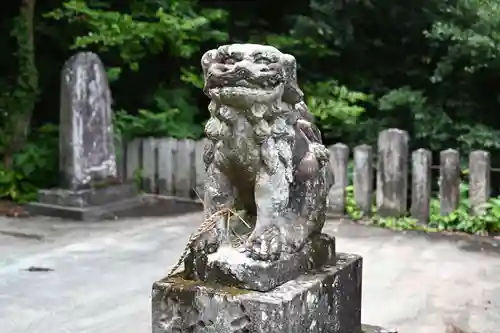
[0,214,500,333]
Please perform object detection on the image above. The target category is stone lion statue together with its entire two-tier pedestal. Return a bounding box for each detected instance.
[156,44,362,333]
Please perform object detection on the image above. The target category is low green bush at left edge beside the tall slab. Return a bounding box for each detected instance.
[0,125,59,203]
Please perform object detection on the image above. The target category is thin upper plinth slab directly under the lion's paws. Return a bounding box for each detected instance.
[195,235,335,291]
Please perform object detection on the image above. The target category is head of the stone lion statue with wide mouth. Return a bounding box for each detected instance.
[201,44,303,107]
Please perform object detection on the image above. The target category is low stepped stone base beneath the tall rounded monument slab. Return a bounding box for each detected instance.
[26,182,142,221]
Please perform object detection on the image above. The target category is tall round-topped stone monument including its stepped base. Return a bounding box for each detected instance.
[27,52,142,220]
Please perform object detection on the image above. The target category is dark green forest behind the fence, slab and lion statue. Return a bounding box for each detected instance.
[0,0,500,233]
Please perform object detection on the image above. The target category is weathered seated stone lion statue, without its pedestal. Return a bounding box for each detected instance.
[195,44,333,261]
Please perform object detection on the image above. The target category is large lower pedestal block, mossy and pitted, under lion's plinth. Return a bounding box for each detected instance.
[152,253,362,333]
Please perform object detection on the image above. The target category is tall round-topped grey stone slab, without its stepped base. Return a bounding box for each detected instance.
[59,52,118,190]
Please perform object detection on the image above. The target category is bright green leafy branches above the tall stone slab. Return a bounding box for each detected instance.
[46,0,227,70]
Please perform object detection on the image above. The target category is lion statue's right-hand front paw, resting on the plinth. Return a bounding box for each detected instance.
[245,227,283,261]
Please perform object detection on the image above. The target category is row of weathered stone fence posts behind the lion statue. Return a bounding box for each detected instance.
[123,129,491,222]
